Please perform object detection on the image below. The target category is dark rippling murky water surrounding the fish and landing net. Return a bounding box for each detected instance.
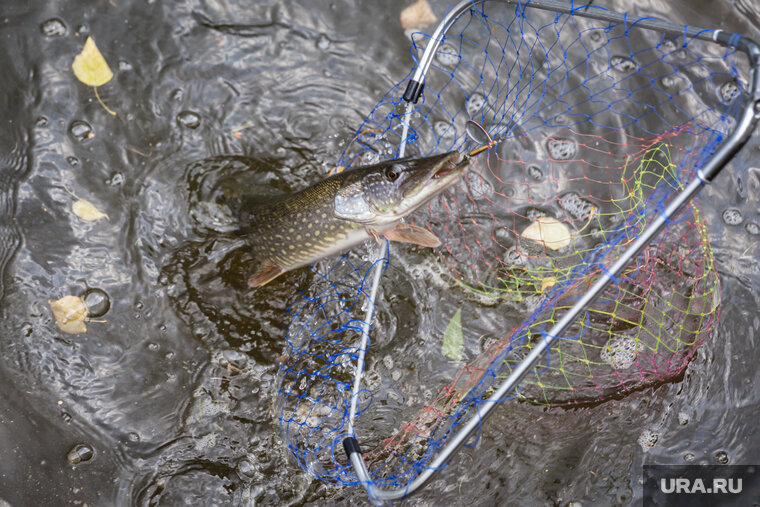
[0,0,760,505]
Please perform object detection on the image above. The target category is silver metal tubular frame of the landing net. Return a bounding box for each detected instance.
[343,0,760,502]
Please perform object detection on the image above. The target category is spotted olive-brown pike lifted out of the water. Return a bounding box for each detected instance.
[245,152,469,287]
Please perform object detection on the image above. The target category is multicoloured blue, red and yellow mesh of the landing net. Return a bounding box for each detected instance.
[277,2,747,487]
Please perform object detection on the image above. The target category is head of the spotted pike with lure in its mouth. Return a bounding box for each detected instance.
[334,151,469,225]
